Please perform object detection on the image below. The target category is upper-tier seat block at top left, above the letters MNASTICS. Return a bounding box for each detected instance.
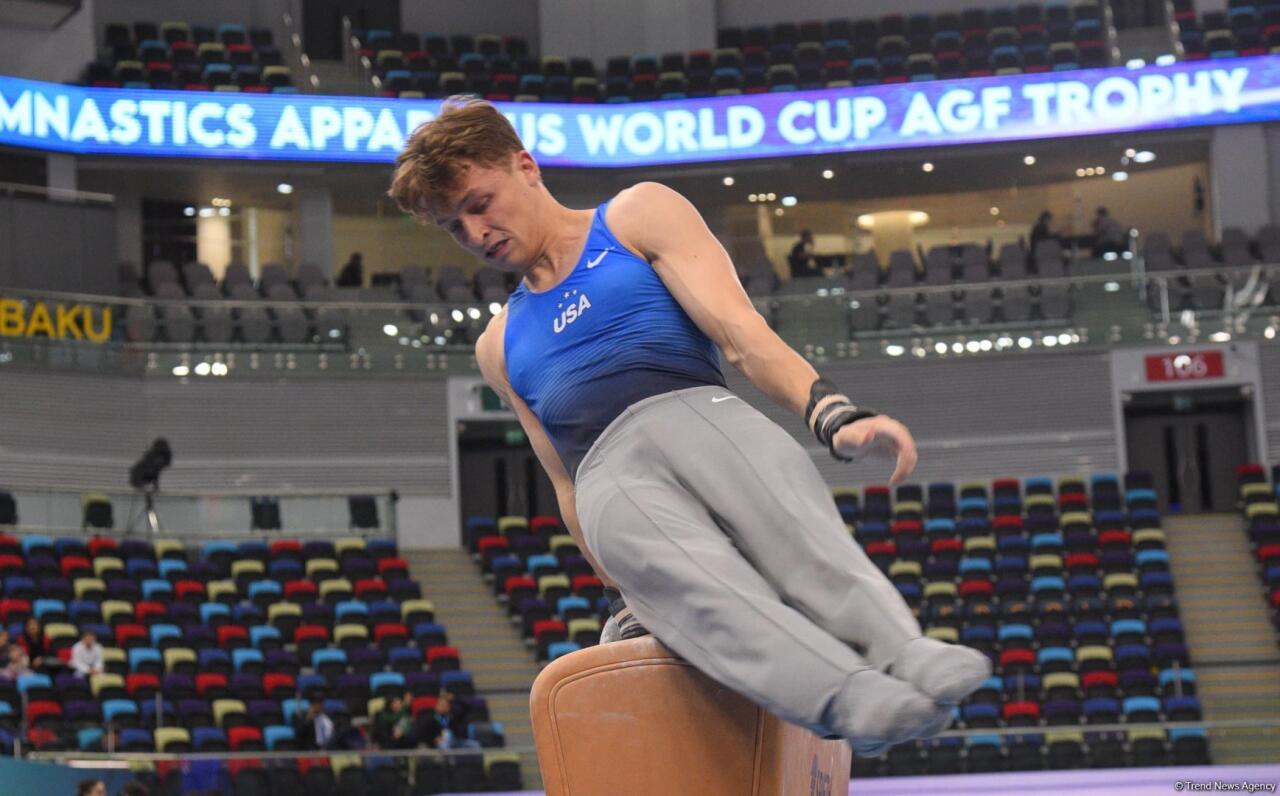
[83,20,297,93]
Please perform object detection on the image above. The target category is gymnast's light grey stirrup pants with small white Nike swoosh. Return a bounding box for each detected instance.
[576,386,920,732]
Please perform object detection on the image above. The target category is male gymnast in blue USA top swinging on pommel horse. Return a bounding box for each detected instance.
[389,99,991,755]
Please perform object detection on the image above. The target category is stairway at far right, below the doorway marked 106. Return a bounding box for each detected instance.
[1165,513,1280,763]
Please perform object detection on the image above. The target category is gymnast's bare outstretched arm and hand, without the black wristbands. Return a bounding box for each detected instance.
[605,183,915,484]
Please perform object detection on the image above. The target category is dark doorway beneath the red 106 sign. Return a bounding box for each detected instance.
[1124,388,1253,513]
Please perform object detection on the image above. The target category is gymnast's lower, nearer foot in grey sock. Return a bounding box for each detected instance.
[832,669,938,756]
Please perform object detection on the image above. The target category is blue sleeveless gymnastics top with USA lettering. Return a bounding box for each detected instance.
[503,202,724,477]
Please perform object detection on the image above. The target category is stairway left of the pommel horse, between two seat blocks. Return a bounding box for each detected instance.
[401,548,541,787]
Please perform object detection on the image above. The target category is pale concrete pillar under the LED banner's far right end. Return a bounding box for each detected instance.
[1210,124,1274,241]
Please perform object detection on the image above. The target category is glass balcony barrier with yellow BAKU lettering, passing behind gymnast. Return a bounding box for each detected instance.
[0,259,1280,378]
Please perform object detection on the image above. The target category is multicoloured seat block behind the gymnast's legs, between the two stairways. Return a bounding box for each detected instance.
[467,474,1208,777]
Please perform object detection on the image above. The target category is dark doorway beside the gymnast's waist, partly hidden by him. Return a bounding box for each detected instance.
[458,420,559,542]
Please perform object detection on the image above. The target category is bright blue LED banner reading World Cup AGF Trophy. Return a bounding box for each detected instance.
[0,55,1280,166]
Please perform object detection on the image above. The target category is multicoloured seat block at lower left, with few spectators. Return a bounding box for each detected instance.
[0,534,520,792]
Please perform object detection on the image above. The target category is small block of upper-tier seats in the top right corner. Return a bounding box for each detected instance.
[1172,0,1280,60]
